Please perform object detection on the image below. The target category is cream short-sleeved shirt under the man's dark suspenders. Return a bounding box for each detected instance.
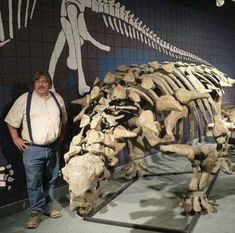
[5,91,67,145]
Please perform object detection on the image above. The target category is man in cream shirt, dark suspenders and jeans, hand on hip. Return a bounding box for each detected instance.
[5,71,67,228]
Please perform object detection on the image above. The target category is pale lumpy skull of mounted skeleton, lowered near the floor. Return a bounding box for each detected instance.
[62,154,110,216]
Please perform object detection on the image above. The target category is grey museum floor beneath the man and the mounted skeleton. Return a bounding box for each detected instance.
[0,143,235,233]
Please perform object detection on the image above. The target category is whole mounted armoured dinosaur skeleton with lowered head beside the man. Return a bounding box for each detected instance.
[62,61,235,215]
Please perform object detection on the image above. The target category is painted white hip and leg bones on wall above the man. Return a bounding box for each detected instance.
[49,0,110,94]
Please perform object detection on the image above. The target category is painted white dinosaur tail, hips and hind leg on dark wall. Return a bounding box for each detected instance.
[49,0,210,95]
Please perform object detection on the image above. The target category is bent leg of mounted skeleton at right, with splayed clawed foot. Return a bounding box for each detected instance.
[160,144,218,212]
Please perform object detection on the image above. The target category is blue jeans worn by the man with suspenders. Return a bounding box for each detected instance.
[23,144,59,213]
